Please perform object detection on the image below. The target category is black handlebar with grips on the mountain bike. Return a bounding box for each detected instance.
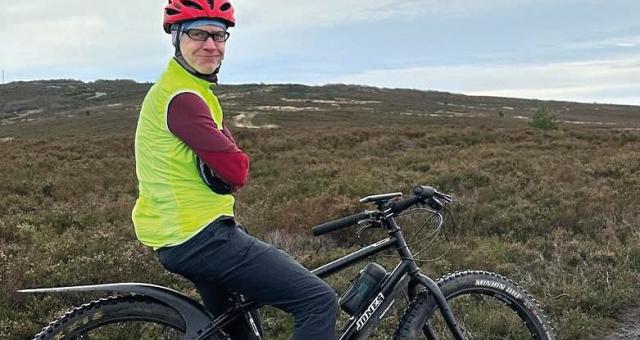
[312,185,453,236]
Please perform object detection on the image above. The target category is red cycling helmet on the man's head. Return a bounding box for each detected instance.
[163,0,236,33]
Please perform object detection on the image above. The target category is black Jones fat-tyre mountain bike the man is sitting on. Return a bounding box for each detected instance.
[20,186,555,340]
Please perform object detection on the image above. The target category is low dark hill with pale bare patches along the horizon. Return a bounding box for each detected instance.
[0,80,640,134]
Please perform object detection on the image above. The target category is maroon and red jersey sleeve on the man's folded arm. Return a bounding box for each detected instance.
[167,92,249,190]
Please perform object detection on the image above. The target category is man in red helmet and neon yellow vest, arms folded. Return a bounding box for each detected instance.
[132,0,336,340]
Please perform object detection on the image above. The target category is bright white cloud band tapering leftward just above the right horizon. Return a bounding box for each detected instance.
[325,56,640,104]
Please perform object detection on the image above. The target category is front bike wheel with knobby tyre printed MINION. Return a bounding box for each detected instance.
[395,271,556,340]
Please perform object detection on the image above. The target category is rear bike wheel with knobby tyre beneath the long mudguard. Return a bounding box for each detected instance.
[34,295,226,340]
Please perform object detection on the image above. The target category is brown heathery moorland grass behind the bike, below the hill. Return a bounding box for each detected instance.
[0,81,640,339]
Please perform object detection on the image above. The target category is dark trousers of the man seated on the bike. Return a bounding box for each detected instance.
[157,218,337,340]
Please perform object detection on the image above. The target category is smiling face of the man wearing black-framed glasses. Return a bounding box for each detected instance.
[180,25,226,74]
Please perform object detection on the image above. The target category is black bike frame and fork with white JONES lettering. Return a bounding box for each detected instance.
[198,217,464,340]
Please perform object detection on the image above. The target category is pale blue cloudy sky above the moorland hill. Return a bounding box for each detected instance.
[0,0,640,105]
